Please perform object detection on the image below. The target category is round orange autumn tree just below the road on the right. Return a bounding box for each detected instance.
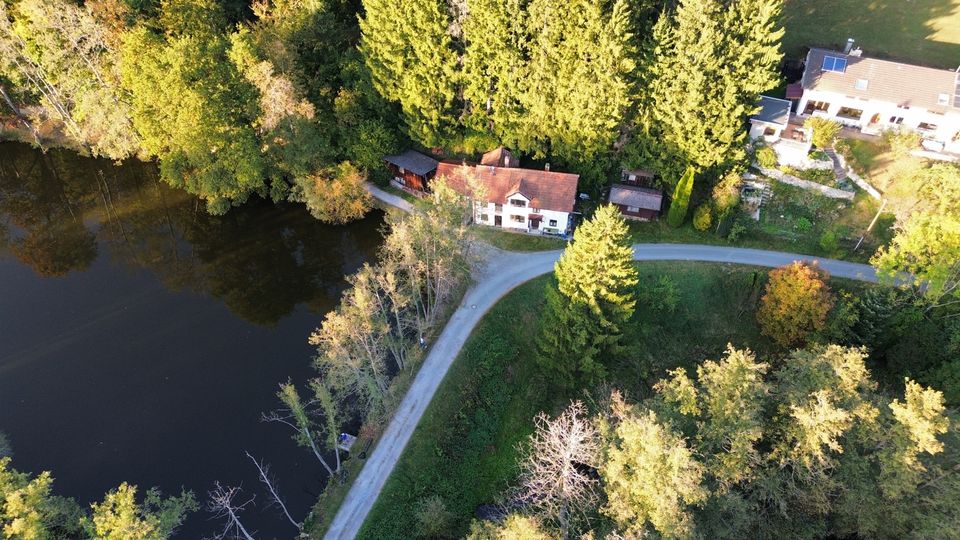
[757,262,835,347]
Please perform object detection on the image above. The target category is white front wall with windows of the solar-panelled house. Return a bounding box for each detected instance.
[797,90,960,147]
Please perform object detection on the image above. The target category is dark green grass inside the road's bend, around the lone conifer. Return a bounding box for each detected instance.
[359,262,824,539]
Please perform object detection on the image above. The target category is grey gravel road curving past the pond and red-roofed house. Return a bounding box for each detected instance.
[325,242,877,540]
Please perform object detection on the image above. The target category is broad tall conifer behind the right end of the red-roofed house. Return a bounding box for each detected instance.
[516,0,635,187]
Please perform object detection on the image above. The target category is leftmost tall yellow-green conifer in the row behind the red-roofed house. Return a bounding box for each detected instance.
[360,0,457,146]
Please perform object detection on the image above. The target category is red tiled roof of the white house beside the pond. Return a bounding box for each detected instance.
[437,161,580,212]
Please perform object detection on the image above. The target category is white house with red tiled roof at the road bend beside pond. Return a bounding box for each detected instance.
[436,147,580,234]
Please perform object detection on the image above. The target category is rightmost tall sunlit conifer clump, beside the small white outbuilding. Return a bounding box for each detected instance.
[636,0,783,173]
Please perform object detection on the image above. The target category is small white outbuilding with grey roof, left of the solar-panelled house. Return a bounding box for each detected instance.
[750,96,813,167]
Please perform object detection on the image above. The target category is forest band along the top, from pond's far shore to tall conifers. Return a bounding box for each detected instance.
[0,0,783,215]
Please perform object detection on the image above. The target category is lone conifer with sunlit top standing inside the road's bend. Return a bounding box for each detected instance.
[537,206,638,385]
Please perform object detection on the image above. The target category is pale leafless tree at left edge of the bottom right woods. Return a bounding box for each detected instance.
[517,401,600,538]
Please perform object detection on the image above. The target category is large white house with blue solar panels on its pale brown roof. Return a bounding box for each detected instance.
[797,42,960,153]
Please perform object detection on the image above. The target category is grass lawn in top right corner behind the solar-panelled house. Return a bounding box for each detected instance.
[783,0,960,69]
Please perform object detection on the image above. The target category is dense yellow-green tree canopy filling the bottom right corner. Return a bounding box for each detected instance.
[496,345,960,539]
